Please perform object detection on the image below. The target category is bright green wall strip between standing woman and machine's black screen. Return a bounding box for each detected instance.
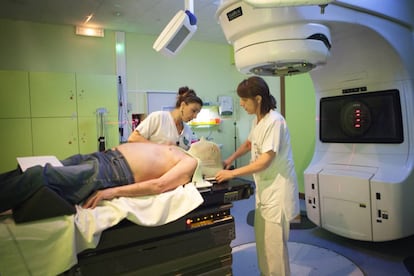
[285,74,316,193]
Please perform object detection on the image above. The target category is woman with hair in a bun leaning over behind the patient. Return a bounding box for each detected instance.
[128,87,203,150]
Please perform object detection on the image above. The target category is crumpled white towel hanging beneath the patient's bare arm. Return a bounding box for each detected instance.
[75,183,203,252]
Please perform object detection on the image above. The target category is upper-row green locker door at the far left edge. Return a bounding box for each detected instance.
[0,71,30,118]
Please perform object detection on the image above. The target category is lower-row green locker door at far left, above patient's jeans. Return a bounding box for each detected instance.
[0,118,33,173]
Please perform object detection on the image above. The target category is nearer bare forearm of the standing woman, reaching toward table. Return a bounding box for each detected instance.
[216,150,276,182]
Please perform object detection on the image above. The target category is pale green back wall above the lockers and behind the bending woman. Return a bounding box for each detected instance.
[0,20,256,166]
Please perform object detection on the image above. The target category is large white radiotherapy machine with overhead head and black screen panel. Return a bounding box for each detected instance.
[216,0,414,241]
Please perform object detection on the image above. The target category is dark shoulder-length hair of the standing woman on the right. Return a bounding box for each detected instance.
[237,76,276,114]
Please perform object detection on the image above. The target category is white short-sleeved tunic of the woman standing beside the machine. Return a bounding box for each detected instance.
[248,111,299,223]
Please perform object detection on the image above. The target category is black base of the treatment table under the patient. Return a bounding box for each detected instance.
[63,179,254,276]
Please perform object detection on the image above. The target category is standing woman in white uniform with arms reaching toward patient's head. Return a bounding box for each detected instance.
[216,76,299,276]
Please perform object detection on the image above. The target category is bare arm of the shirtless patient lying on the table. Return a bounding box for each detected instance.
[83,155,197,208]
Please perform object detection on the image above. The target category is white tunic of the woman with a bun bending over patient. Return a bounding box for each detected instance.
[136,111,193,150]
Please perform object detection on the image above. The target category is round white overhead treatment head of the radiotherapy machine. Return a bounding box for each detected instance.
[217,1,331,76]
